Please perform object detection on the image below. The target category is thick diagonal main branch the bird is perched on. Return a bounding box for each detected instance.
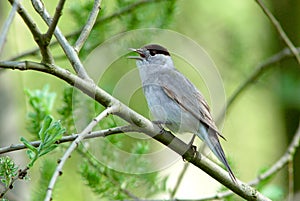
[0,61,269,200]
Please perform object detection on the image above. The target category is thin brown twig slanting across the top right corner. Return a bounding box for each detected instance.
[256,0,300,64]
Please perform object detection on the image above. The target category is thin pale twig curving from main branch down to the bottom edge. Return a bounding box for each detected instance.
[44,105,119,201]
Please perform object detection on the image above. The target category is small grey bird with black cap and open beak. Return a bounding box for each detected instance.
[129,44,236,181]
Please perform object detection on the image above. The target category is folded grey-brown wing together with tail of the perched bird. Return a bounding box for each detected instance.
[157,70,236,182]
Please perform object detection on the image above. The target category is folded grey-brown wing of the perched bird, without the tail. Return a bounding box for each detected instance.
[157,70,225,139]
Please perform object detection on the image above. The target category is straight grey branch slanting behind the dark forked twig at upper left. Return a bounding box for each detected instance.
[31,0,92,82]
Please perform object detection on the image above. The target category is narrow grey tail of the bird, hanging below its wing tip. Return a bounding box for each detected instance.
[199,128,236,183]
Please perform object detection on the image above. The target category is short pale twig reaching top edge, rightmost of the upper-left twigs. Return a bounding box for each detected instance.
[74,0,101,53]
